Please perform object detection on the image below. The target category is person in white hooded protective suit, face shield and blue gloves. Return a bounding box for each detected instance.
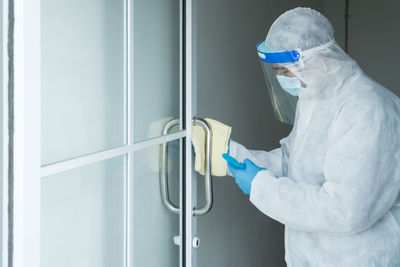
[193,8,400,267]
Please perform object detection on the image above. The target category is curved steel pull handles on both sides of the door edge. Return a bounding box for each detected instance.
[160,117,213,216]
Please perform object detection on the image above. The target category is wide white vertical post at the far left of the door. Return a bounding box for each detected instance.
[12,0,41,267]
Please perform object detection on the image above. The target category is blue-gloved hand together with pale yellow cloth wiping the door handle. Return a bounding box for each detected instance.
[192,118,262,195]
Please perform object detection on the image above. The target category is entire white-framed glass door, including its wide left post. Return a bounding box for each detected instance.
[11,0,205,267]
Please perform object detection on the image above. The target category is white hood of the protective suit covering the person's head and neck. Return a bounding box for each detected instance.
[265,8,362,99]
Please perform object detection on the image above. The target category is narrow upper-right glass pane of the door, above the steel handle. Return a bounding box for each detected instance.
[133,0,180,142]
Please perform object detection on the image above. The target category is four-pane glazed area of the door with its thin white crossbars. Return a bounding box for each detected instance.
[40,0,187,267]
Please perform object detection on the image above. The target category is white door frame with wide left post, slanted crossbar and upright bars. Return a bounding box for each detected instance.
[11,0,200,267]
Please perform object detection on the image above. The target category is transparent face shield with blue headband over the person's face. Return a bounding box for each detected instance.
[257,41,300,125]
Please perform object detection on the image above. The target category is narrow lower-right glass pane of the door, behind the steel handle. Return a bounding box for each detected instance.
[132,140,180,267]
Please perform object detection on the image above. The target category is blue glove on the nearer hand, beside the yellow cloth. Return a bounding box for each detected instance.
[228,156,263,195]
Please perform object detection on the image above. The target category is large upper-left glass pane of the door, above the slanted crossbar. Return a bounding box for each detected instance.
[41,0,124,164]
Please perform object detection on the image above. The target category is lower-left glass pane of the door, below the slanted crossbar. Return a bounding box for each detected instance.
[40,157,124,267]
